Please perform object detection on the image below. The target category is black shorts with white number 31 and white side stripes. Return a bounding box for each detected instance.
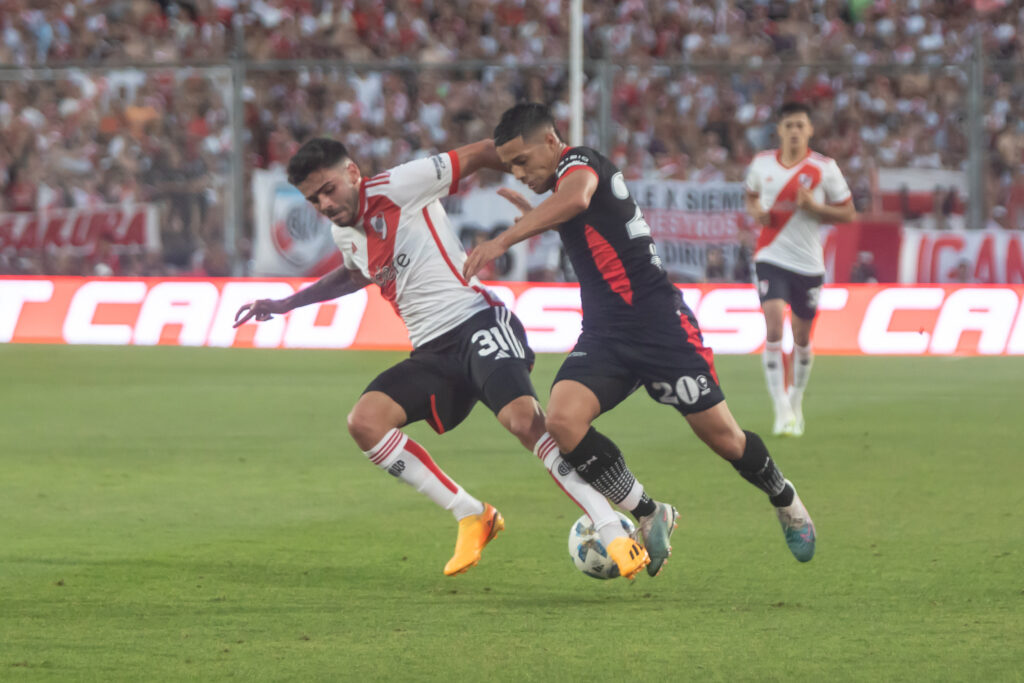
[364,306,537,434]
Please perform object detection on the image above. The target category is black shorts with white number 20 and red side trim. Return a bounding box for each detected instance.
[555,309,725,415]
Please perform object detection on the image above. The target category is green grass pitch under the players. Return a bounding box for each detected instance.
[0,346,1024,682]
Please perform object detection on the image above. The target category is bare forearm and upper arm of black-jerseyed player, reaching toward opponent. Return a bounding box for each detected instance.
[462,173,597,278]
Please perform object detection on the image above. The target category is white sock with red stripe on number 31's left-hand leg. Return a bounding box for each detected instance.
[362,429,483,519]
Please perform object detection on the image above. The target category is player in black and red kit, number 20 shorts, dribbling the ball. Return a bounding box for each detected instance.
[464,103,815,569]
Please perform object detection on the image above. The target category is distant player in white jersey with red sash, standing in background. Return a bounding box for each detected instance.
[746,102,856,436]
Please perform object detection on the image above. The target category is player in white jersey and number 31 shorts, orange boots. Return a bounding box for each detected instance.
[236,138,650,579]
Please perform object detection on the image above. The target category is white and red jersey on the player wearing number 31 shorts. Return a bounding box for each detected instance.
[331,152,501,346]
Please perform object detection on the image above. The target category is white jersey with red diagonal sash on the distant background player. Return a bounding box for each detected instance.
[746,150,852,275]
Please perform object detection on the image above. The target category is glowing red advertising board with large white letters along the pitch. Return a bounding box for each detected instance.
[0,278,1024,355]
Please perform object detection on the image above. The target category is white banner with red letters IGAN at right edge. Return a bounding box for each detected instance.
[899,227,1024,285]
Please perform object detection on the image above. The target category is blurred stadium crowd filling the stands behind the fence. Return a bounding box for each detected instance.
[0,0,1024,274]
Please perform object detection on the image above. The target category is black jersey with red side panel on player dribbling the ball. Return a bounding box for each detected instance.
[555,147,685,337]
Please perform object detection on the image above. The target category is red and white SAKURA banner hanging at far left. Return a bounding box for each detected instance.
[0,204,160,254]
